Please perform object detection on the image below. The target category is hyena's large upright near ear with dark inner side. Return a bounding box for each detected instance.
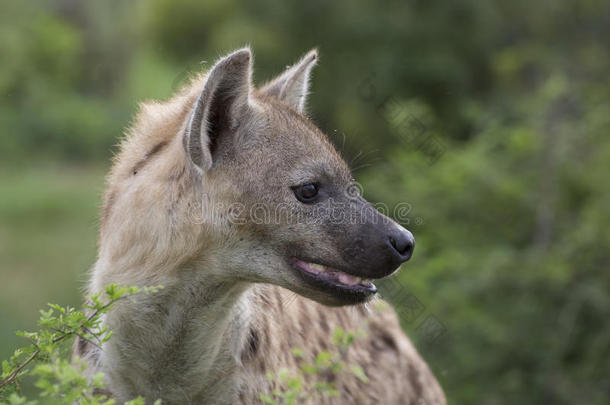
[183,48,252,170]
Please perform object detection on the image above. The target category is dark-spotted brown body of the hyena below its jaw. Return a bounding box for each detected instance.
[239,286,445,404]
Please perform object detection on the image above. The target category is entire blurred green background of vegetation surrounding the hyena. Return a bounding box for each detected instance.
[0,0,610,405]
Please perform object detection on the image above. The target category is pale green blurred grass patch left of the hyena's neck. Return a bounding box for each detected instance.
[0,165,105,359]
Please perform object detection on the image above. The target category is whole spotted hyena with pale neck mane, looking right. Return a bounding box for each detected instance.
[75,48,445,404]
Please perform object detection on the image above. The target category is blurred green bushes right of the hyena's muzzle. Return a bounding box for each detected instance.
[365,36,610,404]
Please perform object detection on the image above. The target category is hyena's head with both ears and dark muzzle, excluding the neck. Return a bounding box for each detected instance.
[177,49,414,305]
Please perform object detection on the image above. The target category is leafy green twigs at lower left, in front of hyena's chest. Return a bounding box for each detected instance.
[0,284,161,405]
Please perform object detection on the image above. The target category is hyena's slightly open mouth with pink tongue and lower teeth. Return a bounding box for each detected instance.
[292,259,377,295]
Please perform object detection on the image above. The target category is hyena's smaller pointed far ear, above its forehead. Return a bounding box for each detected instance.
[261,49,318,112]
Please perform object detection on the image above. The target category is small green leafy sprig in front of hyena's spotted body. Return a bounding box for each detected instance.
[259,326,369,405]
